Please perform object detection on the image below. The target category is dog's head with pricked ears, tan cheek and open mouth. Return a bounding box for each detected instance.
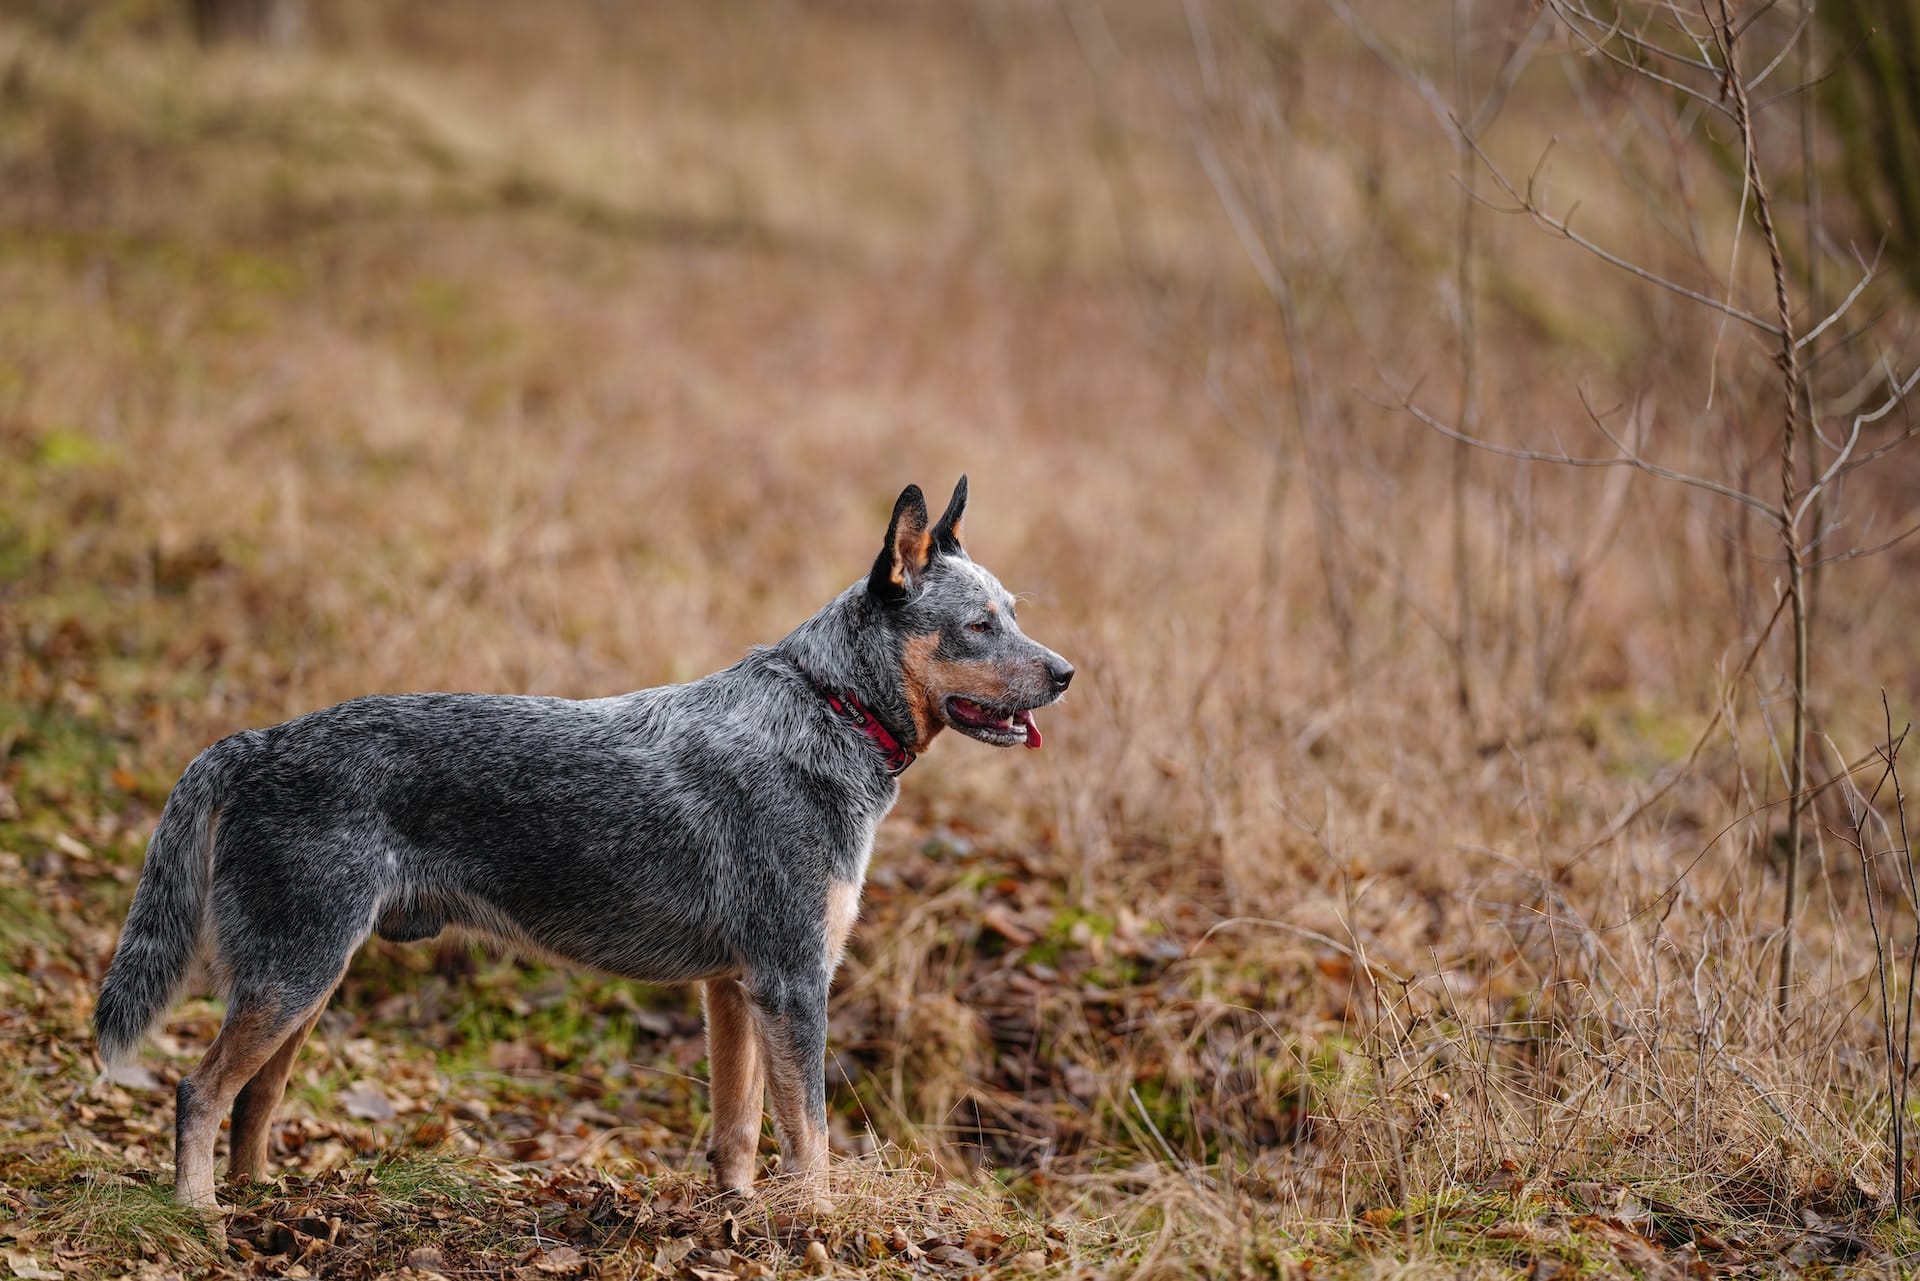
[866,476,1073,747]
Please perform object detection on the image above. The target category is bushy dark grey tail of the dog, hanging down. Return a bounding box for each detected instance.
[94,734,253,1068]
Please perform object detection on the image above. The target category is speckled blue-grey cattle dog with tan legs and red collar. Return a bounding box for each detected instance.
[94,476,1073,1210]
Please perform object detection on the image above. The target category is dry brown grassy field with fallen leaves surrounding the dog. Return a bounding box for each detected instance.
[0,0,1920,1277]
